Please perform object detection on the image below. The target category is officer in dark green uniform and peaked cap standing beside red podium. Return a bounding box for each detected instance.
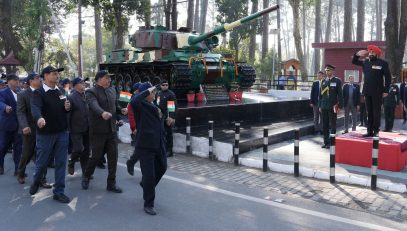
[318,64,343,148]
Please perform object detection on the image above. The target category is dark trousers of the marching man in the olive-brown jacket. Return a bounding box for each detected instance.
[84,133,118,186]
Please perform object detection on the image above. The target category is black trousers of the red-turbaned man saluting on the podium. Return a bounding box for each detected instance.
[365,94,383,133]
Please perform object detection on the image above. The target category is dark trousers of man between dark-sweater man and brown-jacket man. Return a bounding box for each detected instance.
[69,132,90,174]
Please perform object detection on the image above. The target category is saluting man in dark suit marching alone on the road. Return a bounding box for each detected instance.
[131,82,167,215]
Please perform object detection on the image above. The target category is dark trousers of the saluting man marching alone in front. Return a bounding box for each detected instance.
[137,150,167,207]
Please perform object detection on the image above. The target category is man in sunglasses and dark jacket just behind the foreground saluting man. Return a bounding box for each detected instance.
[157,80,177,157]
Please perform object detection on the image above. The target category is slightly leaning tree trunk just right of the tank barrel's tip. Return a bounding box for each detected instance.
[289,0,308,81]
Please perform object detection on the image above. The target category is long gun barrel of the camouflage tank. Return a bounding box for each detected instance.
[188,5,279,45]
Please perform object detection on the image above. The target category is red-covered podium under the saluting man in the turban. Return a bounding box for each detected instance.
[336,132,407,171]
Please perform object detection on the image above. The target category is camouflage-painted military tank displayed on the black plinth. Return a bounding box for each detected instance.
[99,5,278,98]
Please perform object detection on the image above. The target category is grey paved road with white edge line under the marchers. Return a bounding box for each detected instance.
[0,145,407,231]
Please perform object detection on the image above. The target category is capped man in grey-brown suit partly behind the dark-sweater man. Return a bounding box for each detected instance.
[17,72,52,188]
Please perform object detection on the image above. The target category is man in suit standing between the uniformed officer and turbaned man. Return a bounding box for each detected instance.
[343,75,360,134]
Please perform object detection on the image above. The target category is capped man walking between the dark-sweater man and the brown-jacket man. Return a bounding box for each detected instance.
[68,77,90,175]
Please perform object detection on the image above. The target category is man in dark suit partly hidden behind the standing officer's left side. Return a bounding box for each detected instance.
[310,71,325,135]
